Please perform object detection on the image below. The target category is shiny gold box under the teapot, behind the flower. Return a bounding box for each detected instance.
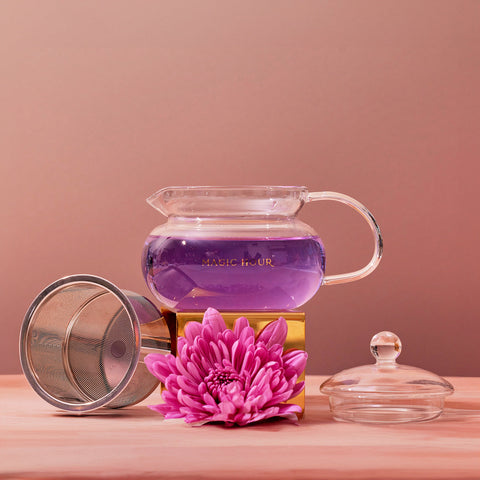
[162,311,305,418]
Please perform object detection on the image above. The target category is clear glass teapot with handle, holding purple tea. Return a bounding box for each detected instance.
[142,186,382,311]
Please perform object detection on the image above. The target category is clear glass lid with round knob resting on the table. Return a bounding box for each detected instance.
[320,332,454,423]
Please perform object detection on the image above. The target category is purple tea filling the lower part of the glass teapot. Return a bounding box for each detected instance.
[142,236,325,311]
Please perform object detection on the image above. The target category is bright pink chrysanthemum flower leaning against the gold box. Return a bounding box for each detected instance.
[145,308,307,426]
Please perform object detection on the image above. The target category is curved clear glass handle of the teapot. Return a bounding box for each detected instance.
[307,192,383,285]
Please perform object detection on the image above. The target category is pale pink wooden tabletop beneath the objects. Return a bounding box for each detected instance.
[0,375,480,480]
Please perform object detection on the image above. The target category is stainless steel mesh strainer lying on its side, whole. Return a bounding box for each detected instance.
[20,275,171,413]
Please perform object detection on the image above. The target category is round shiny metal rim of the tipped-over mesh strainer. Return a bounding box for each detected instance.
[20,274,140,413]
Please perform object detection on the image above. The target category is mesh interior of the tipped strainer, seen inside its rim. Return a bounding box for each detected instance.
[27,284,135,403]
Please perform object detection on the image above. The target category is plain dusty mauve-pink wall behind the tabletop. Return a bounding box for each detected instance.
[0,0,480,376]
